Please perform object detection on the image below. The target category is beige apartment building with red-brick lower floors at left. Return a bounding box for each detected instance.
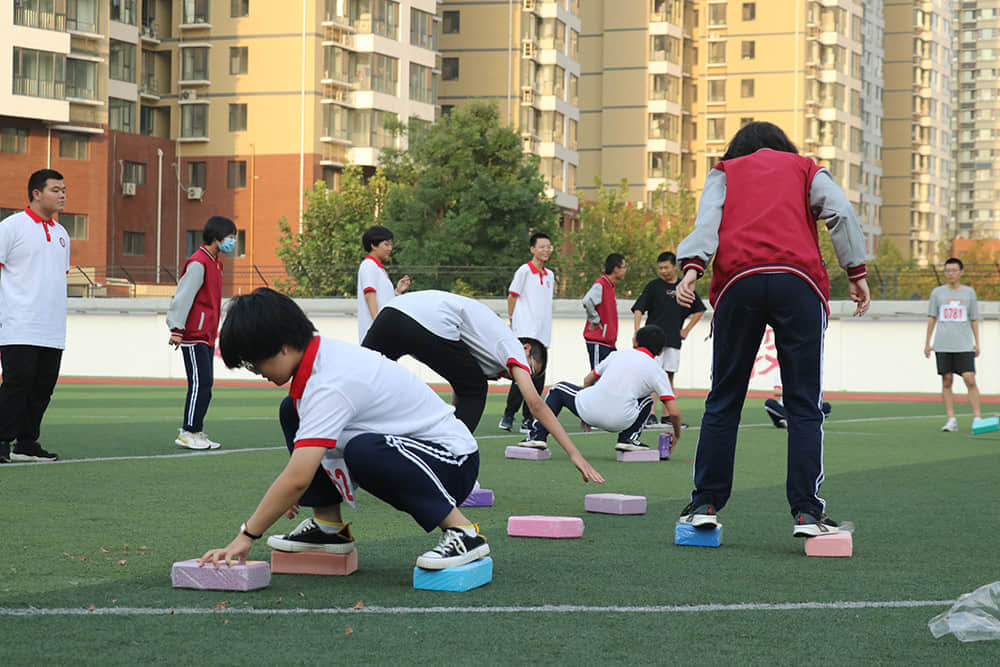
[0,0,439,289]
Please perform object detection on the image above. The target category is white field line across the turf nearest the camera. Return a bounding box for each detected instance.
[0,600,955,617]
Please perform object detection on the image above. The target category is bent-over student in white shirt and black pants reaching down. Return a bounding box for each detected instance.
[362,290,604,482]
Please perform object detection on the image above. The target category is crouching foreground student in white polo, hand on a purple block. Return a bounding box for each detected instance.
[201,287,490,569]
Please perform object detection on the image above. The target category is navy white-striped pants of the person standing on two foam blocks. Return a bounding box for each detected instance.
[691,273,826,515]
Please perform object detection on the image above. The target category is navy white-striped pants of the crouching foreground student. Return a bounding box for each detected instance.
[279,397,479,532]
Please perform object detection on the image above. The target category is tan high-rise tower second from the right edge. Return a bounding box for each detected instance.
[882,0,955,264]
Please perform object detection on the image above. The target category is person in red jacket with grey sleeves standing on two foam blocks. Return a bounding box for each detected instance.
[677,122,871,537]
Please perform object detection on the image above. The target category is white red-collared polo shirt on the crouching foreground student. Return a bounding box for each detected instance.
[288,336,477,456]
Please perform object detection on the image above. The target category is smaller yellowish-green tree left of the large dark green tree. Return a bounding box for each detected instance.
[278,166,393,296]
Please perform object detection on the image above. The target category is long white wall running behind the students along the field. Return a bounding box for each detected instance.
[62,298,1000,394]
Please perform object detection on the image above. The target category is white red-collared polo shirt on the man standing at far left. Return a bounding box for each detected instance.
[0,209,69,350]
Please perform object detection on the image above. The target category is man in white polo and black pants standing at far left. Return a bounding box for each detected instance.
[0,169,69,463]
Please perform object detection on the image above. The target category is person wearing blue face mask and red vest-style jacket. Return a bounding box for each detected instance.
[167,215,236,449]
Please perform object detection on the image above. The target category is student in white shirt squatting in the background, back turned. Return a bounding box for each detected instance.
[520,325,681,452]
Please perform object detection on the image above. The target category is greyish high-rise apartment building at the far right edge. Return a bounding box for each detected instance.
[952,0,1000,238]
